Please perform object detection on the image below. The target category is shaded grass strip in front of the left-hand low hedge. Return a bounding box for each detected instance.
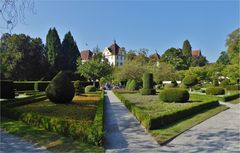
[0,118,104,153]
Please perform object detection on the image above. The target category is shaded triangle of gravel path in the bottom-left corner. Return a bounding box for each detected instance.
[0,129,51,153]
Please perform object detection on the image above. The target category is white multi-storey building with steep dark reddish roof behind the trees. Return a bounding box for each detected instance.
[103,40,125,66]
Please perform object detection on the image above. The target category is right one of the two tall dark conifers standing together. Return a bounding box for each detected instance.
[62,31,80,71]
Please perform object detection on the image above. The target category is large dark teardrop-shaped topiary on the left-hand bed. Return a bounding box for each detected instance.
[46,71,75,103]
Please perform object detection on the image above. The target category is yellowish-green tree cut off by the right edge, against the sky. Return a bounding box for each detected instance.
[226,28,240,64]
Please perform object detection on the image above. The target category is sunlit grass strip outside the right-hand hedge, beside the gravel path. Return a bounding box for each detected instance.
[149,106,227,144]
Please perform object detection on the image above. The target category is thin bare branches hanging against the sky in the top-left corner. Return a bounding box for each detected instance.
[0,0,34,33]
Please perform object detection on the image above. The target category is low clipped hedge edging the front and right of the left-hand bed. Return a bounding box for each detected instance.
[2,91,104,145]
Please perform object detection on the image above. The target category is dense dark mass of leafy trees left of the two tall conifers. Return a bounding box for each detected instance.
[0,34,48,80]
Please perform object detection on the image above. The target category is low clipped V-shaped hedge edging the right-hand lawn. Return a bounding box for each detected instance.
[114,91,219,130]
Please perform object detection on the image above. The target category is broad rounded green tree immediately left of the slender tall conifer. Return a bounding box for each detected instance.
[161,48,188,70]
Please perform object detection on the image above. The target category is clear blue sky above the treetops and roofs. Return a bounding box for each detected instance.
[0,0,240,62]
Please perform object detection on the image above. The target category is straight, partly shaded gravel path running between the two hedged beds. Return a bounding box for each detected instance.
[104,91,160,153]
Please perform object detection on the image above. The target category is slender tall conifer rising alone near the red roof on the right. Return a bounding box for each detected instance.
[182,40,192,67]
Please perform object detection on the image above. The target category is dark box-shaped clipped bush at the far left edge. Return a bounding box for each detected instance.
[0,80,15,99]
